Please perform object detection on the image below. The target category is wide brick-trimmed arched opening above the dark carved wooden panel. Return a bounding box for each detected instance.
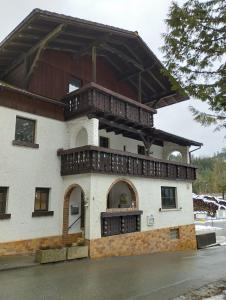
[107,179,138,209]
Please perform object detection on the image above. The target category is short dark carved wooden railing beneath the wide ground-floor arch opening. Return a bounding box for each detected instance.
[101,210,142,236]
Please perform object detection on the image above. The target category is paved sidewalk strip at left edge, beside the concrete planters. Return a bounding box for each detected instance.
[0,254,39,271]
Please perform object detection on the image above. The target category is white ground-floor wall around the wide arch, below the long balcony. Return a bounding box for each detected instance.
[90,174,194,239]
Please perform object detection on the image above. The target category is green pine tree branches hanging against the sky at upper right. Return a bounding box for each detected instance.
[162,0,226,129]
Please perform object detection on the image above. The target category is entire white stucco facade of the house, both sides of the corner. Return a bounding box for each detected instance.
[0,107,193,243]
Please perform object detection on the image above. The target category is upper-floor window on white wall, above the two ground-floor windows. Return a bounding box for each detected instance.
[15,117,35,144]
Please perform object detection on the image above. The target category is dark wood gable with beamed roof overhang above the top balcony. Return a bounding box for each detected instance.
[0,9,187,108]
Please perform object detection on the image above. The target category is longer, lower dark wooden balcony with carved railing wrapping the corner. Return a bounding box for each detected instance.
[58,146,196,181]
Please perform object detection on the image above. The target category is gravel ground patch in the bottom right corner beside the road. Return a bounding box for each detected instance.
[174,280,226,300]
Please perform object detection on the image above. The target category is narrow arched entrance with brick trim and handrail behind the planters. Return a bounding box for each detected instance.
[63,184,85,241]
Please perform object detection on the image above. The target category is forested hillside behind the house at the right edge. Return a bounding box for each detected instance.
[192,148,226,198]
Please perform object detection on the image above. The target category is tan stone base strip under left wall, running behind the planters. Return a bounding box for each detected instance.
[0,233,82,256]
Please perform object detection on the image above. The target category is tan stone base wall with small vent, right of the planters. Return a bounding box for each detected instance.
[89,224,197,258]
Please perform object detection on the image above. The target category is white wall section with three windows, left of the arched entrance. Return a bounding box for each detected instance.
[0,107,68,242]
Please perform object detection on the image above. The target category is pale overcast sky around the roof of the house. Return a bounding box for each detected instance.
[0,0,226,155]
